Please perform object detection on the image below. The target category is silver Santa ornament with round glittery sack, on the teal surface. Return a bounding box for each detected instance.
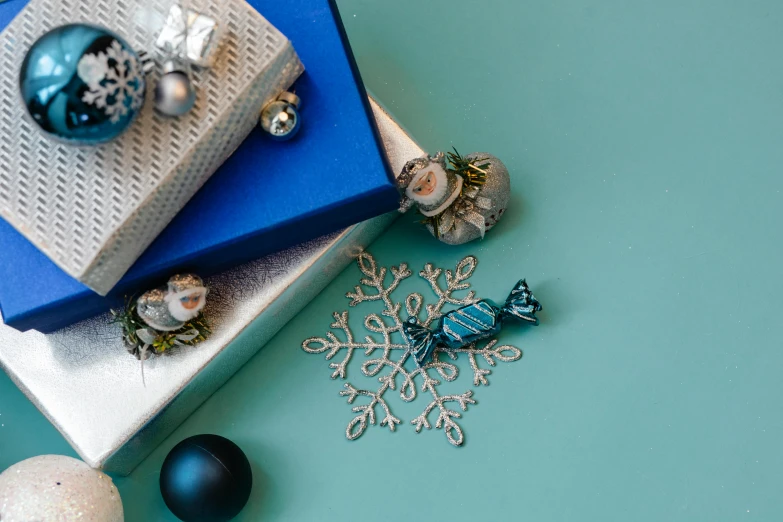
[397,149,511,245]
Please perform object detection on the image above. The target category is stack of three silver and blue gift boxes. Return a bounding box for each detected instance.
[0,0,422,473]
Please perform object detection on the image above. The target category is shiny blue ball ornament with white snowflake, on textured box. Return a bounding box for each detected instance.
[19,24,146,145]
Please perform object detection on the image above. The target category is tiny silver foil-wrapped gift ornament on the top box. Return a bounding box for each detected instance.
[155,0,222,67]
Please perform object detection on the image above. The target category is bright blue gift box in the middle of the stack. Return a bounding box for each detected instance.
[0,0,398,333]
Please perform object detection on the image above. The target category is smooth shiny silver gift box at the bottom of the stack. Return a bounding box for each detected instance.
[0,99,423,475]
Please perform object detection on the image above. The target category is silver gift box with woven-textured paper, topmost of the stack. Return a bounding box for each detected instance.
[0,0,303,294]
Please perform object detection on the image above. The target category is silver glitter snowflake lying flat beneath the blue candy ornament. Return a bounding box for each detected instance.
[302,252,522,446]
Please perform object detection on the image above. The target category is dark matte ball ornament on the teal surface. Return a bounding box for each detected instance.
[160,435,253,522]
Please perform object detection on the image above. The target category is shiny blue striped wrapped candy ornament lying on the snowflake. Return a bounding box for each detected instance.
[402,279,542,366]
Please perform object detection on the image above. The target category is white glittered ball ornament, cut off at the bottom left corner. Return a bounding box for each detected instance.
[0,455,124,522]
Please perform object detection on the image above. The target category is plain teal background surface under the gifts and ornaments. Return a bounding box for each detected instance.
[0,0,783,522]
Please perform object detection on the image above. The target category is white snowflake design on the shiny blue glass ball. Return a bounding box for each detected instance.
[77,40,145,123]
